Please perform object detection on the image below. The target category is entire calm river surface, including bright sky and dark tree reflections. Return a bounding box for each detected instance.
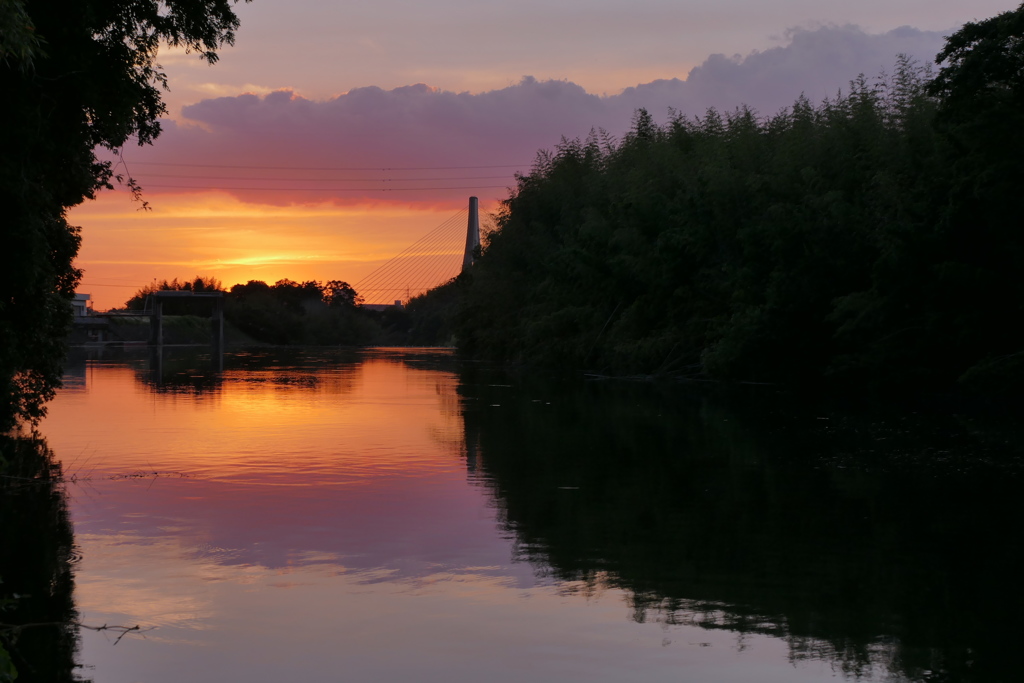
[34,349,1024,683]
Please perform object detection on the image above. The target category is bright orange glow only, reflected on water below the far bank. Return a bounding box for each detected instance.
[43,350,461,485]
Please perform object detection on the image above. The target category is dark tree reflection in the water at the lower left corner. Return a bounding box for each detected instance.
[0,436,86,683]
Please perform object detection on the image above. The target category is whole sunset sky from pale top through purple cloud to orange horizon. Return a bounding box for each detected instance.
[71,0,1015,309]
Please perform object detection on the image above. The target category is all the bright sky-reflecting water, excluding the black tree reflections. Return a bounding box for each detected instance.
[42,349,856,683]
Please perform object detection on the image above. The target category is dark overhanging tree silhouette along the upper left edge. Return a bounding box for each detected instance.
[0,0,245,430]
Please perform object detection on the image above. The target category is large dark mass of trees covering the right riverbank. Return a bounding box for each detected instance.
[456,6,1024,390]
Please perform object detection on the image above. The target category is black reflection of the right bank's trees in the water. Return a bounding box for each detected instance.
[463,376,1024,681]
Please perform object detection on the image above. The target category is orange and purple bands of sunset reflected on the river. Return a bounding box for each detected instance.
[43,349,495,589]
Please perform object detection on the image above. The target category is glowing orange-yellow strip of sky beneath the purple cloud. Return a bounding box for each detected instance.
[69,191,487,309]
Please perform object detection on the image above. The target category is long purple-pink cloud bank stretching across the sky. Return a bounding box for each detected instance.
[126,26,943,204]
